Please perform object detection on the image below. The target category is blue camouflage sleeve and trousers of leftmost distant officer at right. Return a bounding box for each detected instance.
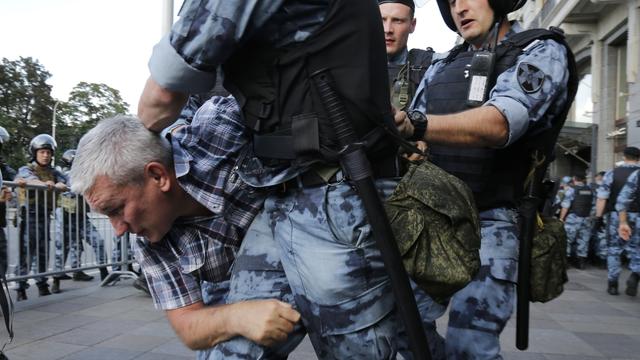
[560,183,591,258]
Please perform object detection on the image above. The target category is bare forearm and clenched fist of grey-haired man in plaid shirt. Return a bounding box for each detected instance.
[166,300,300,350]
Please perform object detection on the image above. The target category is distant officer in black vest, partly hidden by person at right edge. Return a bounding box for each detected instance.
[596,146,640,295]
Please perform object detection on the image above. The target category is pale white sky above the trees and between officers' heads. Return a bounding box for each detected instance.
[0,0,456,114]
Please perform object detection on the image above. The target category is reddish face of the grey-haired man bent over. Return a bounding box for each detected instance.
[85,176,176,242]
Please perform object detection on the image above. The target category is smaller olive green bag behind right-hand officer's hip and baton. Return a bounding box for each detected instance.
[529,217,569,302]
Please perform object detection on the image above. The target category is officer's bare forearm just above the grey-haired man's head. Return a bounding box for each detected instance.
[138,77,189,132]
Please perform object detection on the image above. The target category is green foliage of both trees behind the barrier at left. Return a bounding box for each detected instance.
[0,57,129,168]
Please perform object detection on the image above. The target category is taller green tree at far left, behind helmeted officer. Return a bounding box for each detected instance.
[0,57,55,168]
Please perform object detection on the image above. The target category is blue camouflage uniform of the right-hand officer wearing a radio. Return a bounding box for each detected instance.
[411,22,569,359]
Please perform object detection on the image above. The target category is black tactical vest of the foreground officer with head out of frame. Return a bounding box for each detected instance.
[223,0,397,168]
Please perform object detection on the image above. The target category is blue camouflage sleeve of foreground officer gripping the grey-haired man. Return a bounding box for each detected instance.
[149,0,329,94]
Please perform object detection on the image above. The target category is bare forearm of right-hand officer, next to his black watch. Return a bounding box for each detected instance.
[426,106,509,146]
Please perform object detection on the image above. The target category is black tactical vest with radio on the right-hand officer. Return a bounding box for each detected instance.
[426,29,578,210]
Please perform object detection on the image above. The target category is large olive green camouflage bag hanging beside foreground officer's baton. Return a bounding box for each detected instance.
[385,161,480,302]
